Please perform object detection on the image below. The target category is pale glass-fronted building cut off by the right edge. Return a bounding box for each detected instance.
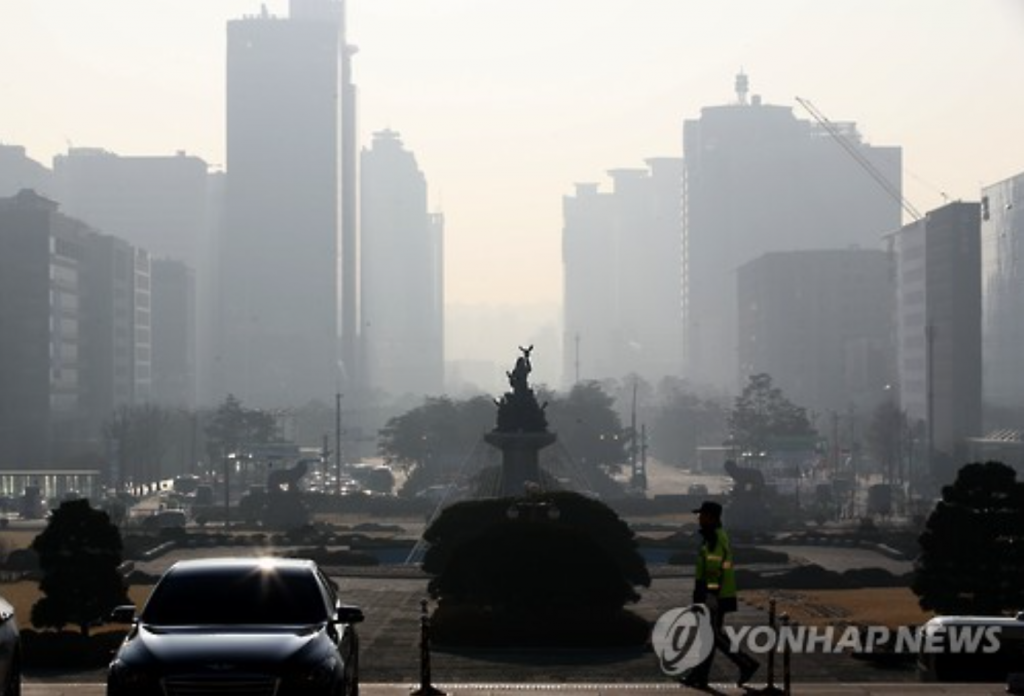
[981,173,1024,421]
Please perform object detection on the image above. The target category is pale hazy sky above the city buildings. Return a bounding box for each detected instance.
[0,0,1024,304]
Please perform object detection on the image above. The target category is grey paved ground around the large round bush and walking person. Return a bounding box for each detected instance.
[28,559,929,693]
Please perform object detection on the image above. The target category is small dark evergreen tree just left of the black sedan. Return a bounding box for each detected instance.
[32,499,129,636]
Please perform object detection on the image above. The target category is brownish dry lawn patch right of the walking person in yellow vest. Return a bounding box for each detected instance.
[741,588,934,628]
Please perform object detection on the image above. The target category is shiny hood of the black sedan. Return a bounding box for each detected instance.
[121,624,327,671]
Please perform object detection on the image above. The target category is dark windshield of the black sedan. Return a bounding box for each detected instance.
[141,567,328,626]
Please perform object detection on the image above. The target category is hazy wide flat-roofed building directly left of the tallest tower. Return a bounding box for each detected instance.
[53,147,209,406]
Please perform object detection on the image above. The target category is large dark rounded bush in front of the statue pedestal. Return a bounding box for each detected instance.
[423,491,650,644]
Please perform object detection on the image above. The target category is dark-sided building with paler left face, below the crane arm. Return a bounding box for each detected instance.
[891,202,982,485]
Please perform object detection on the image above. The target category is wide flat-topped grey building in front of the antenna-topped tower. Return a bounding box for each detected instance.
[736,249,894,416]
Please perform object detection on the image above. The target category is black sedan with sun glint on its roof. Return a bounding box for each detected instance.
[106,558,362,696]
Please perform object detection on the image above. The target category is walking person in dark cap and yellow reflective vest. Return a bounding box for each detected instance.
[683,501,760,689]
